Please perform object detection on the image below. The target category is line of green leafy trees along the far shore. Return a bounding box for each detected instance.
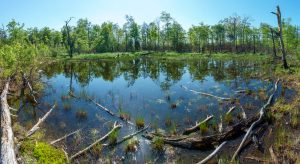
[0,12,300,57]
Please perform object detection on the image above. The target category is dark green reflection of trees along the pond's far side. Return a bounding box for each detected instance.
[44,58,271,91]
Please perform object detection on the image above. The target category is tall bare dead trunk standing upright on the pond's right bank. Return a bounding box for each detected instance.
[272,6,289,69]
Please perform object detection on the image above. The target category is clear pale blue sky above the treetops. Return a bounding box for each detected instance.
[0,0,300,29]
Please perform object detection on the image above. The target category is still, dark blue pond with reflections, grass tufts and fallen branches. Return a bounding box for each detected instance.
[13,57,290,163]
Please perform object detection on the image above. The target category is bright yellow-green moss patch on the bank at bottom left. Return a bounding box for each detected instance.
[20,140,67,164]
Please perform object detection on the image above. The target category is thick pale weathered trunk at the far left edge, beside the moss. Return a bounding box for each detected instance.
[0,78,17,164]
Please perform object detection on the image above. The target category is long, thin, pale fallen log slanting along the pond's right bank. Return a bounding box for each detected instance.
[231,79,280,162]
